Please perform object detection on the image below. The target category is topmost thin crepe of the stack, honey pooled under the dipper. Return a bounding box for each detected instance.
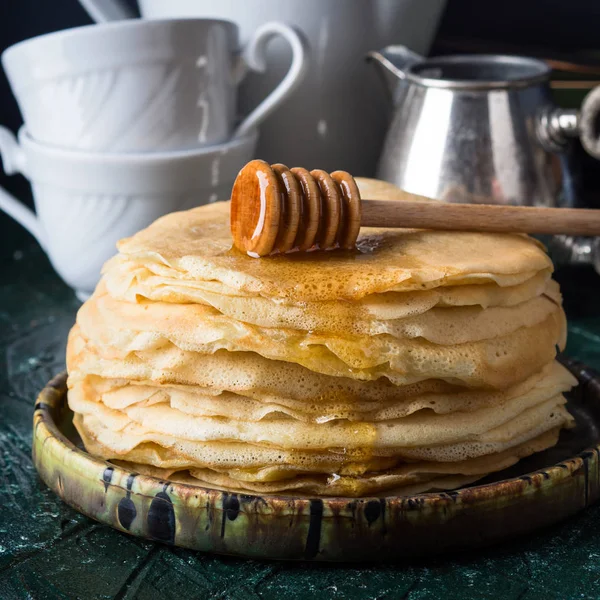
[107,202,552,302]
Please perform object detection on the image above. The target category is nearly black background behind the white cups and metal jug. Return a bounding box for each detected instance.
[0,0,600,264]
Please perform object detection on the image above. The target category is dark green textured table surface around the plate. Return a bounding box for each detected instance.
[0,226,600,600]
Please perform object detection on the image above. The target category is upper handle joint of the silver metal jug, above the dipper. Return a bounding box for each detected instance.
[538,86,600,160]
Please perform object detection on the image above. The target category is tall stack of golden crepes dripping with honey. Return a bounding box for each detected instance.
[67,180,576,496]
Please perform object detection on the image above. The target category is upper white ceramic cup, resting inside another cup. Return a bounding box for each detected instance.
[2,19,306,152]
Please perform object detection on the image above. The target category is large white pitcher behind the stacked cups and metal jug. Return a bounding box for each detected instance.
[80,0,445,175]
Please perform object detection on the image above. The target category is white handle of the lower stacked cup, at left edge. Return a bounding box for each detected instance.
[0,126,46,249]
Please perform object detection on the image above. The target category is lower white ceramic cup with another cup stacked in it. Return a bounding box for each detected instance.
[0,127,257,299]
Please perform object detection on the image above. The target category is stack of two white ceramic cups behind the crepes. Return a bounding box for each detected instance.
[0,19,306,299]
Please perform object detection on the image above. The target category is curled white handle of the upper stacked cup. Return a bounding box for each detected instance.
[234,21,308,138]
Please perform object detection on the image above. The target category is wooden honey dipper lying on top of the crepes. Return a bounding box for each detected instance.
[231,160,600,257]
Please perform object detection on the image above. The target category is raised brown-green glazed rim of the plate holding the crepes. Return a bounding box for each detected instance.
[33,359,600,561]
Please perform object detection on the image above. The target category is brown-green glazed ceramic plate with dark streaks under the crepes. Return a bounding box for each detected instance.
[33,361,600,561]
